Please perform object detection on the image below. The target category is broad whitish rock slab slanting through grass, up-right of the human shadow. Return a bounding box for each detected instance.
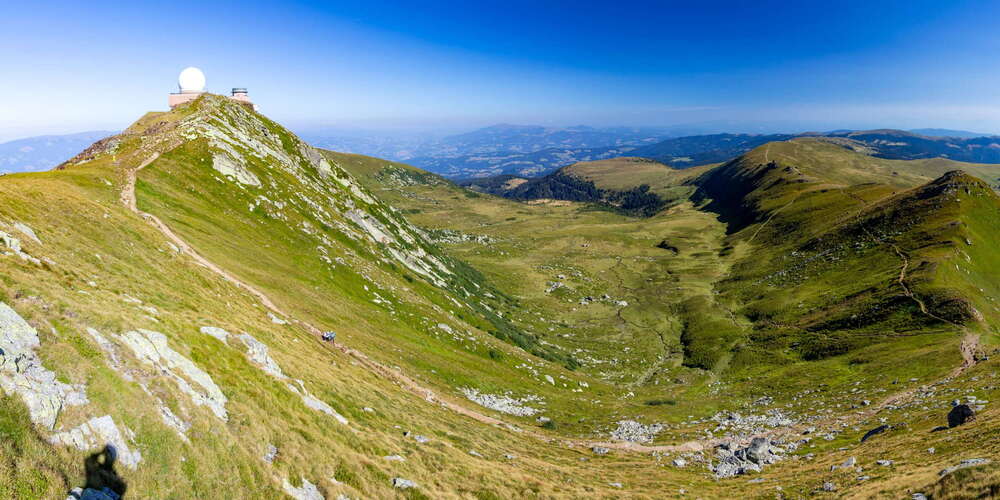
[120,330,229,420]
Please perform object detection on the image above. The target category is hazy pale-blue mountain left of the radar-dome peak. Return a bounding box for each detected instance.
[0,130,114,174]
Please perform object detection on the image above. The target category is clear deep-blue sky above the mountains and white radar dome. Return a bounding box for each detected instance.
[0,0,1000,139]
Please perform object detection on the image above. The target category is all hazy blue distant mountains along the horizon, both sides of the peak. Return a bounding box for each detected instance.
[7,124,1000,179]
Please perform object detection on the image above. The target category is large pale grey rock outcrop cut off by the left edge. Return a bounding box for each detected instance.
[0,302,88,429]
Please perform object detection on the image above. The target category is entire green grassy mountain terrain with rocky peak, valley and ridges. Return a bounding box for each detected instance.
[0,95,1000,499]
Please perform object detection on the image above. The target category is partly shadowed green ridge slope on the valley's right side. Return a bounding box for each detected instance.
[696,140,1000,366]
